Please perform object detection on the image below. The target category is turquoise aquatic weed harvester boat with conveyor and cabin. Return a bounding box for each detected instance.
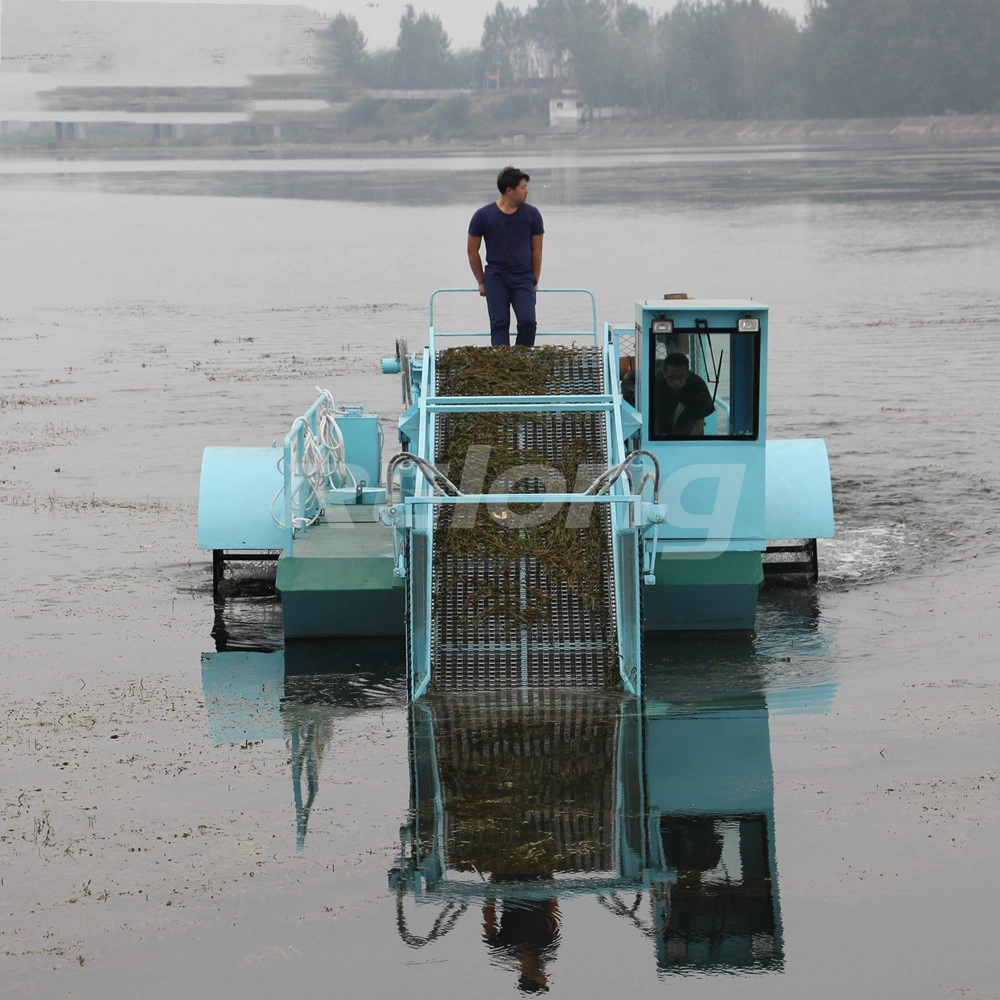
[198,289,833,699]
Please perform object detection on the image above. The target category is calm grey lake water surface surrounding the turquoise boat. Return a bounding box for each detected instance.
[0,150,1000,1000]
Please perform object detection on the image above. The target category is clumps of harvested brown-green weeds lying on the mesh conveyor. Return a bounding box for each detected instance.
[435,346,611,632]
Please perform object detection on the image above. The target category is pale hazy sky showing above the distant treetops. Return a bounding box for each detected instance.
[78,0,808,51]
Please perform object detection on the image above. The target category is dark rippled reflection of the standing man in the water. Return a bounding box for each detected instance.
[483,875,559,993]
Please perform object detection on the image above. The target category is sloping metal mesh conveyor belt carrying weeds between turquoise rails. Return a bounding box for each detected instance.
[430,347,619,691]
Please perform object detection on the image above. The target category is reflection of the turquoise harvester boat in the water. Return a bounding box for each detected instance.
[202,594,835,990]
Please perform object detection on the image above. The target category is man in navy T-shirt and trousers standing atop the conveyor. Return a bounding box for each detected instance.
[467,167,545,347]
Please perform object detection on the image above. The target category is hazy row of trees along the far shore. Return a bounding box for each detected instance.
[322,0,1000,120]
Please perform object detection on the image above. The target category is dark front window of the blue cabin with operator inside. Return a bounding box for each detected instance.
[648,320,760,441]
